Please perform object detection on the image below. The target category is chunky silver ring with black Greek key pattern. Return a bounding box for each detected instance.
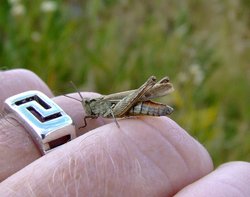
[4,90,76,155]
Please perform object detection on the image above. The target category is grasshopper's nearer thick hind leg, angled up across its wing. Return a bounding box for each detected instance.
[112,76,156,117]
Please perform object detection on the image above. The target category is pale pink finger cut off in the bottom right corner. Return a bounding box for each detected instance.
[176,162,250,197]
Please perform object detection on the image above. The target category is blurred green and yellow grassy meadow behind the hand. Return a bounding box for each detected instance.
[0,0,250,166]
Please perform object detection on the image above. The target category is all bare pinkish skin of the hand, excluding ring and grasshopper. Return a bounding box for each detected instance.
[0,69,250,197]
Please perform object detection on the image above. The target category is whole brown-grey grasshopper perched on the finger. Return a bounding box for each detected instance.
[67,76,174,128]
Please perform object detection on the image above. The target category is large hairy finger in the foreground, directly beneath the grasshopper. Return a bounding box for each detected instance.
[0,118,213,196]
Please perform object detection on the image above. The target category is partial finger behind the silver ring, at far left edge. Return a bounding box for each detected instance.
[0,69,53,110]
